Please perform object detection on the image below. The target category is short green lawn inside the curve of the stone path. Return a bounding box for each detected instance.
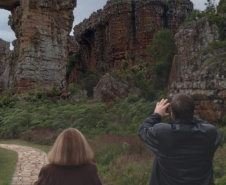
[0,148,18,185]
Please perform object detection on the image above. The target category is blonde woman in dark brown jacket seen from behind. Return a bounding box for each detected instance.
[35,128,101,185]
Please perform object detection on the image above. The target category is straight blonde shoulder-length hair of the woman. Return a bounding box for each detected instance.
[48,128,93,166]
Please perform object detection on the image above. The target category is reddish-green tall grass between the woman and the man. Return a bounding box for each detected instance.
[91,135,153,185]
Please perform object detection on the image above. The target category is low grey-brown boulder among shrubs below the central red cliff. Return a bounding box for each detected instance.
[94,73,140,102]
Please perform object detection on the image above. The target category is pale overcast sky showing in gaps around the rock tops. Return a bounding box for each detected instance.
[0,0,219,47]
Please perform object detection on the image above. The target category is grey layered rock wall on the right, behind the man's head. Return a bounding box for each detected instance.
[168,18,226,123]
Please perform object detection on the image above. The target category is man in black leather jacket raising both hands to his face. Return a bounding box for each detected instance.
[138,93,222,185]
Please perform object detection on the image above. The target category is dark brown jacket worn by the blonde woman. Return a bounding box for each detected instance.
[34,163,101,185]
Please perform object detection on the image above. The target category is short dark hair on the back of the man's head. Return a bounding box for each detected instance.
[170,93,195,120]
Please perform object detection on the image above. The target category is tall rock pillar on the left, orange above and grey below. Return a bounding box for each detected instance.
[0,0,76,92]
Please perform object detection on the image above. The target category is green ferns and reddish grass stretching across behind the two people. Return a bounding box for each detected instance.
[0,94,226,185]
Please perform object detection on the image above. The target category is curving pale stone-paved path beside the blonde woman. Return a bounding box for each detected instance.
[0,144,48,185]
